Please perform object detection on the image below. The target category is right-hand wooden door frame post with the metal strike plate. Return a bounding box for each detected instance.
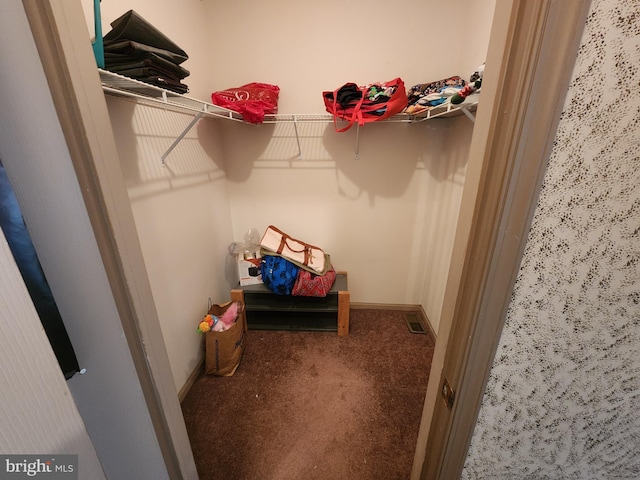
[411,0,590,480]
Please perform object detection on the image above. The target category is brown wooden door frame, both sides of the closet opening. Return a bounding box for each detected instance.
[23,0,590,479]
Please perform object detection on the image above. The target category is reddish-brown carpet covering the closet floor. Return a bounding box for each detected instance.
[182,310,434,480]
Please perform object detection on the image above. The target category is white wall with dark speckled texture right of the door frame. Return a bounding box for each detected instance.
[463,0,640,480]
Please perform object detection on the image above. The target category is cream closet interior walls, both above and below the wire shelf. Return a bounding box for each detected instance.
[83,0,495,390]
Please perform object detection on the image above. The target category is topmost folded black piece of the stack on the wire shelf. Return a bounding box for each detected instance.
[103,10,189,63]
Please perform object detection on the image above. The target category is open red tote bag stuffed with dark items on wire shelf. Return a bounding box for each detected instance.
[322,78,408,132]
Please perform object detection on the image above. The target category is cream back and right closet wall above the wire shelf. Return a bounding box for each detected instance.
[204,0,495,113]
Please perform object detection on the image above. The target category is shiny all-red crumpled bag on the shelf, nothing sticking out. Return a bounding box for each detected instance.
[211,82,280,123]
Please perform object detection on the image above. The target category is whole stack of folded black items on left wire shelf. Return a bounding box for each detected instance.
[103,10,189,94]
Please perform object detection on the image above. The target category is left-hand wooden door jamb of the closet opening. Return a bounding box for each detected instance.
[22,0,198,479]
